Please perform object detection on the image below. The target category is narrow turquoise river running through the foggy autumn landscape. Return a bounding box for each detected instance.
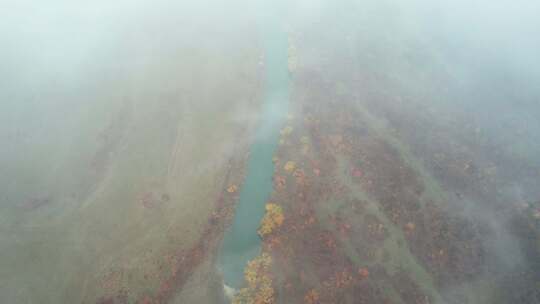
[218,18,289,288]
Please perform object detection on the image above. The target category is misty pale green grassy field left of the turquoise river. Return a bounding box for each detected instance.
[0,22,259,303]
